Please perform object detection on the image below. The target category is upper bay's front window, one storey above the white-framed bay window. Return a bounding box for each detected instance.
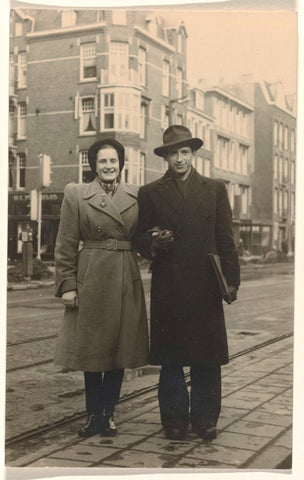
[109,42,129,83]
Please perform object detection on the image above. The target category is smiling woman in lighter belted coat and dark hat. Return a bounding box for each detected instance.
[55,139,148,437]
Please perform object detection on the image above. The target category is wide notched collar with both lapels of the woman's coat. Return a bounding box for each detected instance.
[83,180,137,225]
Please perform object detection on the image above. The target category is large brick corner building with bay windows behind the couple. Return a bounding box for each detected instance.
[8,9,187,258]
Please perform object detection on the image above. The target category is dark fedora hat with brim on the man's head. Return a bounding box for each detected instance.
[154,125,204,157]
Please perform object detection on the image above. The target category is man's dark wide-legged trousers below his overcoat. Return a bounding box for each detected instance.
[158,359,221,429]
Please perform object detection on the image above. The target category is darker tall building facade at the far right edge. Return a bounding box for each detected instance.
[252,81,296,254]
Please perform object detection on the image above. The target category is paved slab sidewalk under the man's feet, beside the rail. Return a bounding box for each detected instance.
[16,338,293,466]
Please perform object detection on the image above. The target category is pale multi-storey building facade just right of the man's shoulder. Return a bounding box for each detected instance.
[205,87,254,251]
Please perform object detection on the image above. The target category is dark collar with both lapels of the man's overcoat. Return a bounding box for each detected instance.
[156,169,209,214]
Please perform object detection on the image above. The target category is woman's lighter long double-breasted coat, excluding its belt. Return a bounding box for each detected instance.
[55,180,148,372]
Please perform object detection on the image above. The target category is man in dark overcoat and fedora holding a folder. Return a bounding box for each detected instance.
[134,125,240,440]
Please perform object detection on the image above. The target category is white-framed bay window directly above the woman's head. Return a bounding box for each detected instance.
[100,88,141,133]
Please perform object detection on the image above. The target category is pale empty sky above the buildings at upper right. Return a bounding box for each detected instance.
[160,7,297,93]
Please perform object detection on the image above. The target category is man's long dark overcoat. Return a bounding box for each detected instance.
[133,171,240,365]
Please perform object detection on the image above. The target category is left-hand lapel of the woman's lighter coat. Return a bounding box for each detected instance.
[83,180,124,225]
